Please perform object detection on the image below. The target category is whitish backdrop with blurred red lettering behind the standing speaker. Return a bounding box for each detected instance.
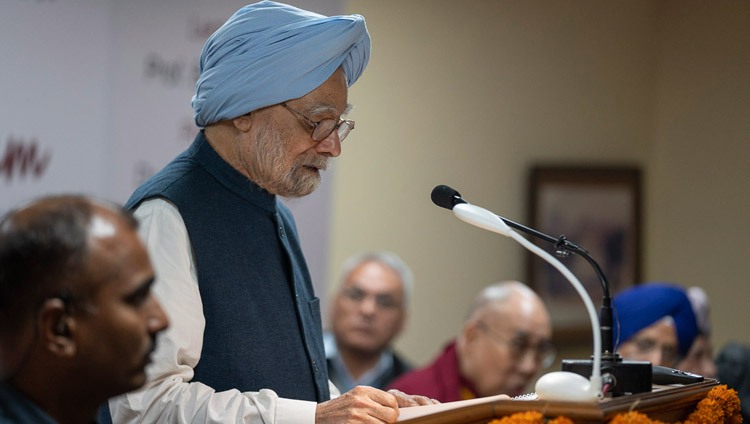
[0,0,343,296]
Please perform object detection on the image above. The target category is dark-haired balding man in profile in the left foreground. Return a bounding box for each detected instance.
[0,196,168,424]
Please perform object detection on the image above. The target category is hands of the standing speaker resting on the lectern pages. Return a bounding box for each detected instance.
[315,386,438,424]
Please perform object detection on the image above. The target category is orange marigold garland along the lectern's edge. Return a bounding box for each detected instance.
[488,385,742,424]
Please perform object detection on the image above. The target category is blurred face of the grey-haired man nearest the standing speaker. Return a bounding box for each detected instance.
[331,262,406,355]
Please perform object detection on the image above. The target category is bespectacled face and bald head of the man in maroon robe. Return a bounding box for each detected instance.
[459,295,554,396]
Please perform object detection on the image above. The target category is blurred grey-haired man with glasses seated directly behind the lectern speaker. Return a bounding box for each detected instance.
[324,252,414,393]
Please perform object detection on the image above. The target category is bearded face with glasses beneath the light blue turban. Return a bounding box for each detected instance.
[228,69,354,197]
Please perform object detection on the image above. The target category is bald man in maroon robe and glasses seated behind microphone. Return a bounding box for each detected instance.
[390,281,555,402]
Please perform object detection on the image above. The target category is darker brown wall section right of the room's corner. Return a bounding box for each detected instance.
[645,1,750,356]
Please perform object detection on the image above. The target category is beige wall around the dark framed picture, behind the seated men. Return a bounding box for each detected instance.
[329,0,750,363]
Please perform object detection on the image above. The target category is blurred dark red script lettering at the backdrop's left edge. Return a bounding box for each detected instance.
[0,135,52,182]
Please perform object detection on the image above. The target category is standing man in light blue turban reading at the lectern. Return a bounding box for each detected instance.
[103,1,438,424]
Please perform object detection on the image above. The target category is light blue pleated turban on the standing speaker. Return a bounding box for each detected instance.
[193,1,370,128]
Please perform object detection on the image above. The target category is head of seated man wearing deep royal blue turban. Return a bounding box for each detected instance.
[613,282,698,367]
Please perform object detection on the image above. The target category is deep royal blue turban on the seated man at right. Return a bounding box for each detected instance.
[613,283,698,356]
